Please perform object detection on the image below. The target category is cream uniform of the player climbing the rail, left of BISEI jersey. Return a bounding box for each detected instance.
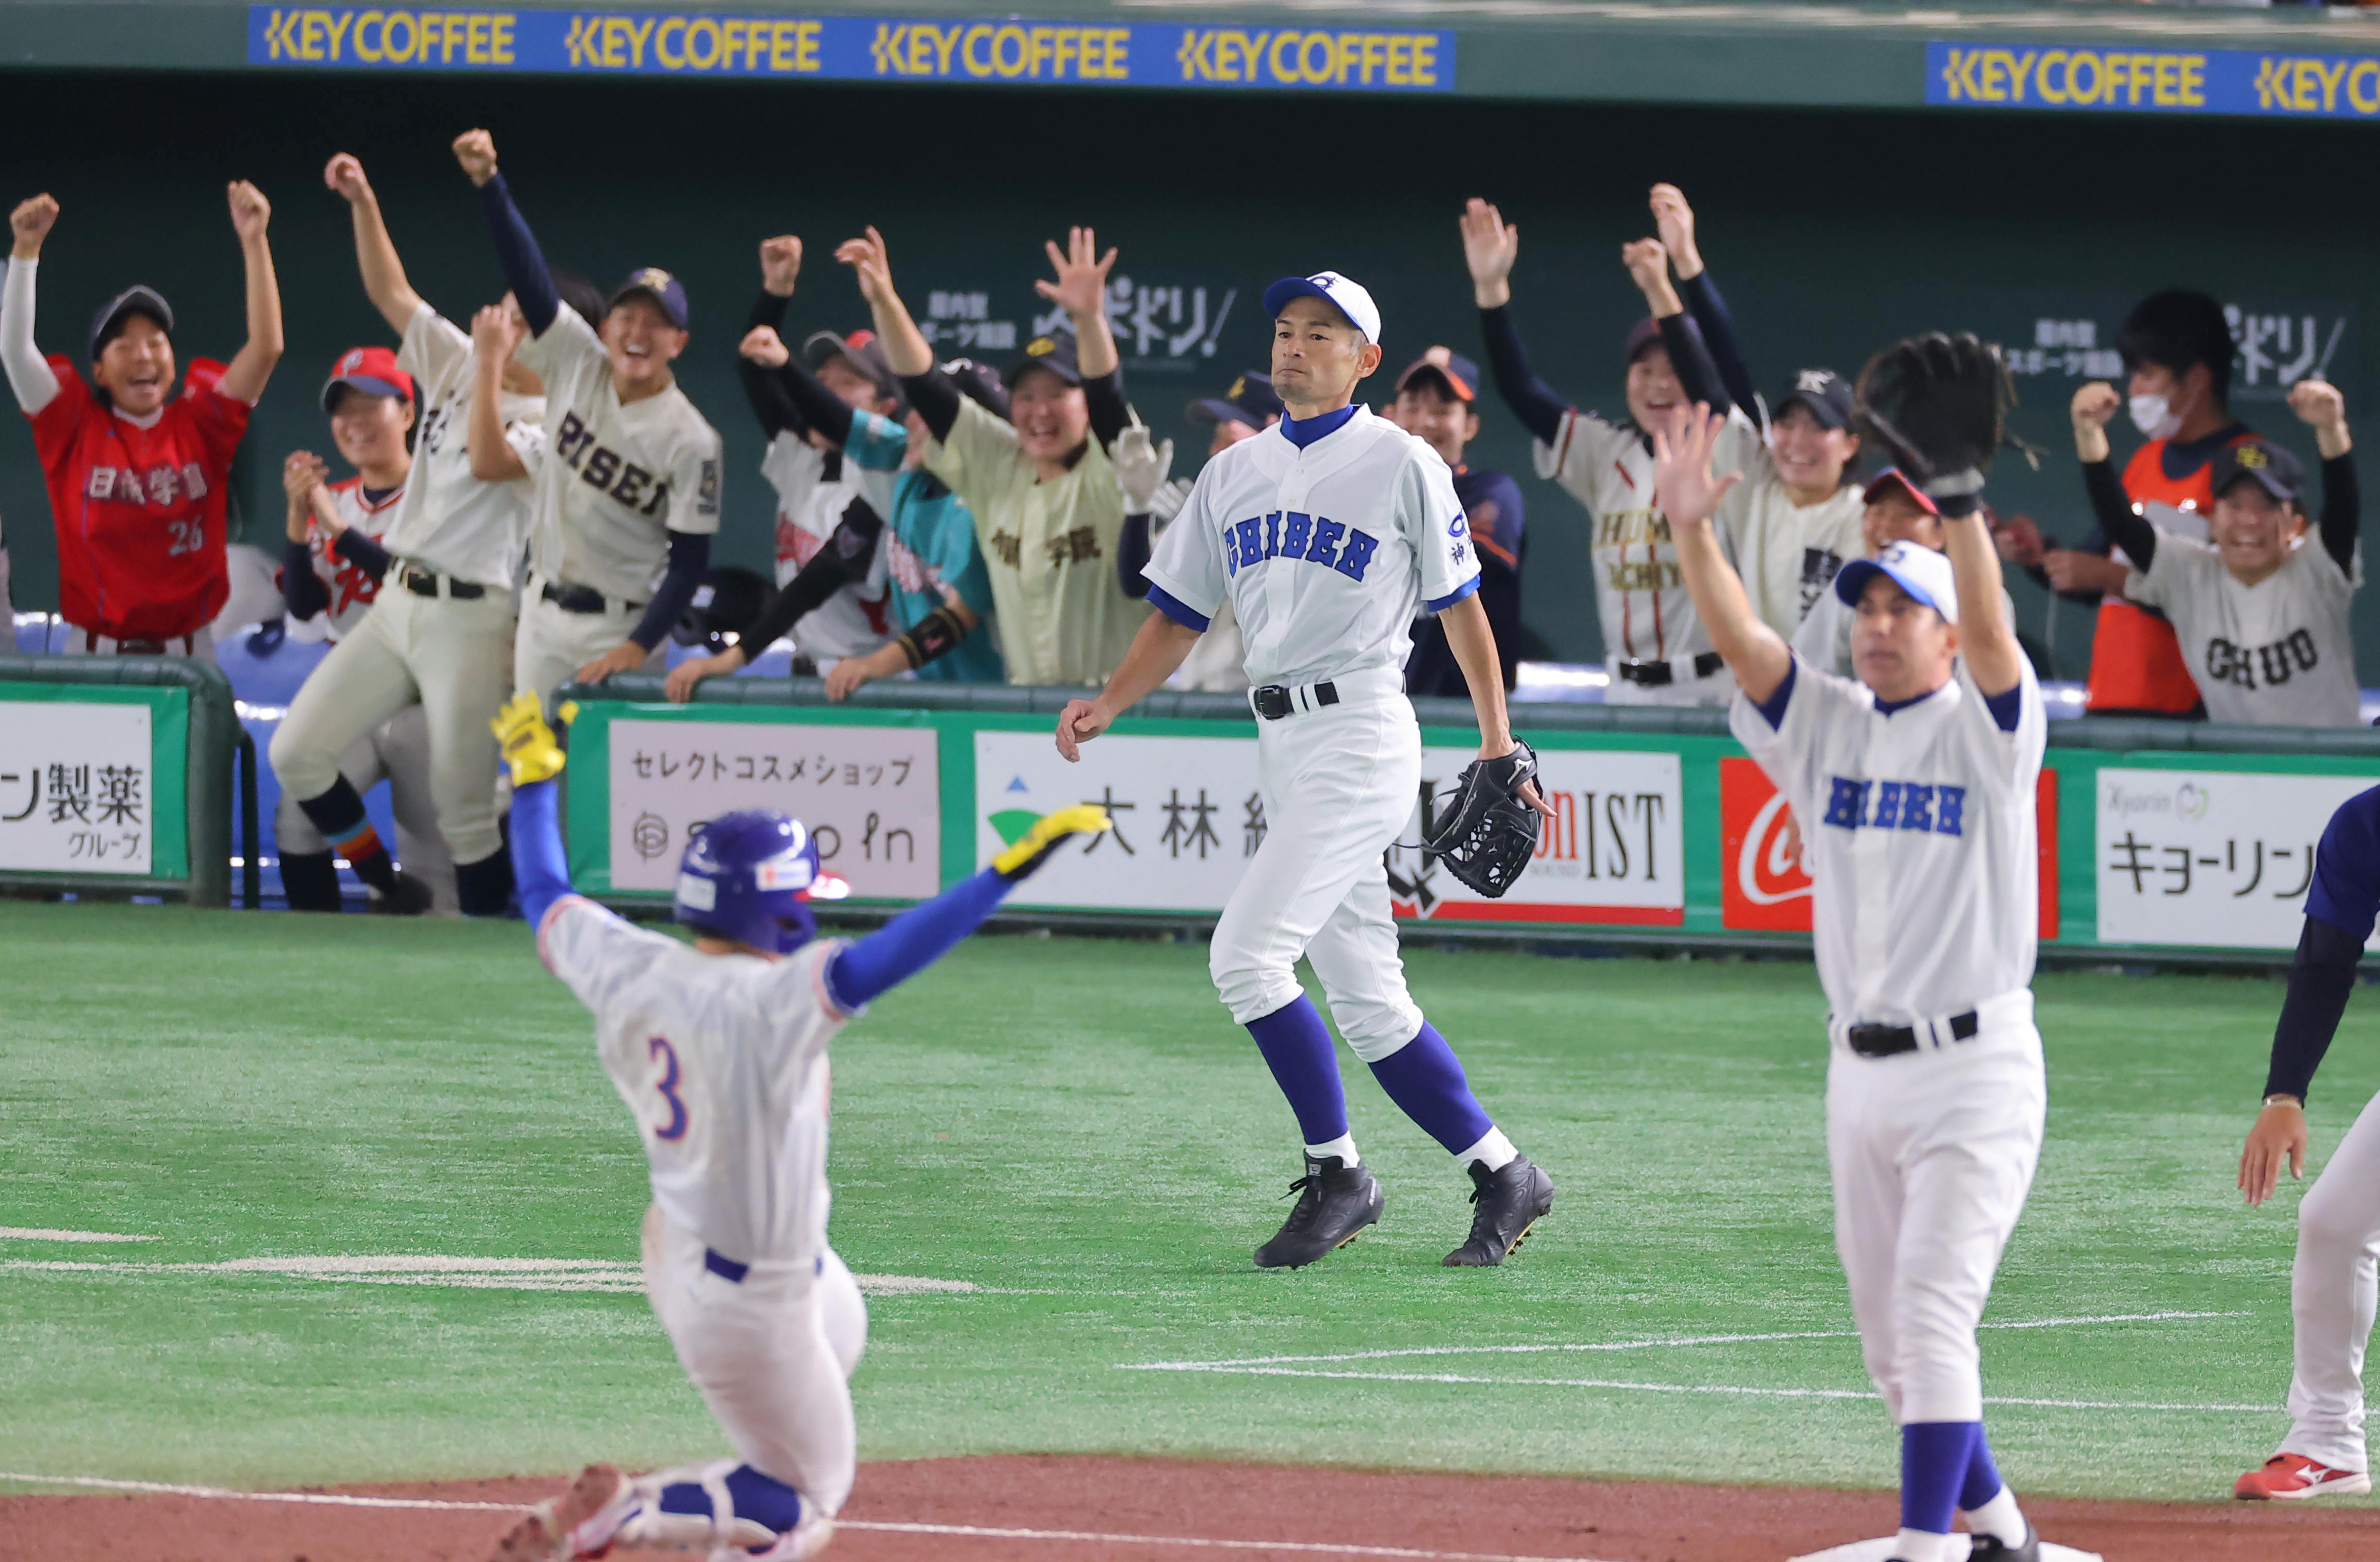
[272,305,545,867]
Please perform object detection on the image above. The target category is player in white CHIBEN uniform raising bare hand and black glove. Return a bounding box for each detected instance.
[1657,336,2047,1562]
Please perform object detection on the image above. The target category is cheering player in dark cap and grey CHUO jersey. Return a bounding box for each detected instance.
[2102,393,2363,726]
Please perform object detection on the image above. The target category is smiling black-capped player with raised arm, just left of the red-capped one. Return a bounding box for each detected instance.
[1652,183,1875,641]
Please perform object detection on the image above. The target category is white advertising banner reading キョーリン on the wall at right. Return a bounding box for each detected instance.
[2097,767,2373,950]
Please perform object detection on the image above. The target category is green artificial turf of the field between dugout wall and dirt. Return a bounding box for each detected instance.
[0,902,2380,1498]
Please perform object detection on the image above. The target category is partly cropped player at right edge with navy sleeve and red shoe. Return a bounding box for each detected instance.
[2237,781,2380,1503]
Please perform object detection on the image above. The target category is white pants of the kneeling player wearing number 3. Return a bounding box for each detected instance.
[645,1205,868,1517]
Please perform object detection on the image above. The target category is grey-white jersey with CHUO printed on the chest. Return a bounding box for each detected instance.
[2123,531,2363,726]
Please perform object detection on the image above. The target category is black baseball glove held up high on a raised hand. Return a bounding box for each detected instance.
[1852,331,2016,515]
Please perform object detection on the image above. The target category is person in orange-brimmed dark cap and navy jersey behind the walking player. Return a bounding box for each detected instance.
[1388,347,1528,700]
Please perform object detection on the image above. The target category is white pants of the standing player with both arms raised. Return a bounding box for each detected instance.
[1826,993,2049,1426]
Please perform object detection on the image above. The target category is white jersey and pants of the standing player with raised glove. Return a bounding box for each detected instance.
[1730,660,2047,1426]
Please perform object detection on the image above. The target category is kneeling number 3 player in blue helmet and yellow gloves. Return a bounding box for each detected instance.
[495,690,1107,1562]
